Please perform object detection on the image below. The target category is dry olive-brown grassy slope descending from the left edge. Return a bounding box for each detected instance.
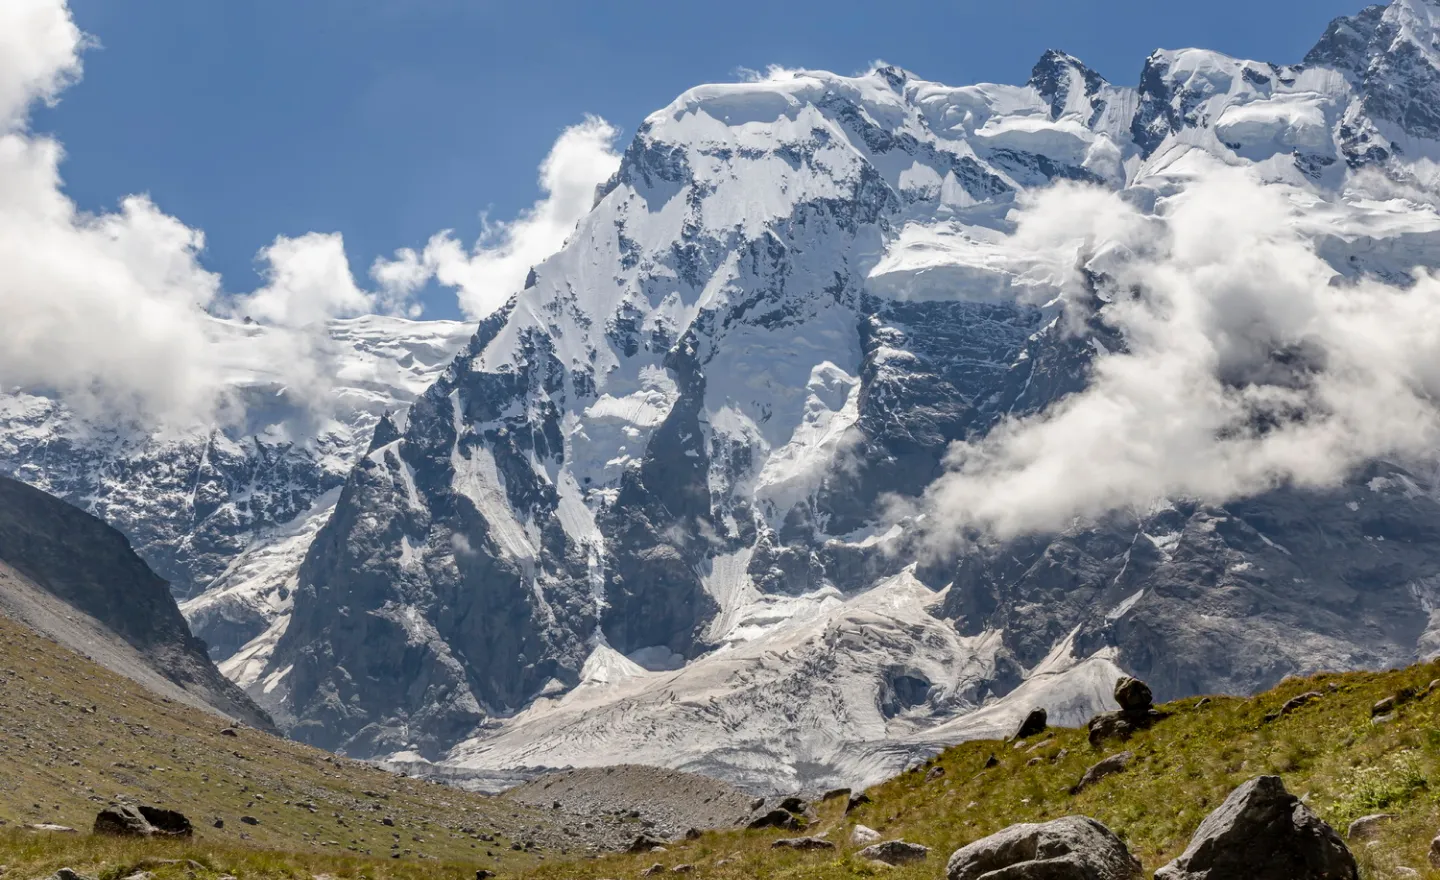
[0,618,587,877]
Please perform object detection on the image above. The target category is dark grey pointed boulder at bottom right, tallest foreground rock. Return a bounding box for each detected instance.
[1155,776,1359,880]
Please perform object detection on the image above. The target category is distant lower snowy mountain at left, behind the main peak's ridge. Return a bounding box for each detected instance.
[0,315,471,660]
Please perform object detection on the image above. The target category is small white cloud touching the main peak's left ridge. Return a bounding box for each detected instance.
[372,117,621,318]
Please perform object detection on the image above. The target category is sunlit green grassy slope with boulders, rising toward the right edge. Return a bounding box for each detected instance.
[531,664,1440,880]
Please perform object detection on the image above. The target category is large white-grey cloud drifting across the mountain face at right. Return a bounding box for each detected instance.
[923,161,1440,540]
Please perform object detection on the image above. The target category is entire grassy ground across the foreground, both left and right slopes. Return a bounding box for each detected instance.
[8,599,1440,880]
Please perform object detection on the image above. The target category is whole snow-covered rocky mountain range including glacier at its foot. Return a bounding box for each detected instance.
[8,0,1440,791]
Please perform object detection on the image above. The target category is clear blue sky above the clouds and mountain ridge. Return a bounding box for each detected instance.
[32,0,1361,317]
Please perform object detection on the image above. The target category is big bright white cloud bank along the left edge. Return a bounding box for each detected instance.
[0,0,413,426]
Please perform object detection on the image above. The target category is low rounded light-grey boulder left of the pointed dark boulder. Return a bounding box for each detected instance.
[946,815,1142,880]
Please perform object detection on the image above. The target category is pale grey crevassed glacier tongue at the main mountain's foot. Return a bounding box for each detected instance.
[440,570,1120,792]
